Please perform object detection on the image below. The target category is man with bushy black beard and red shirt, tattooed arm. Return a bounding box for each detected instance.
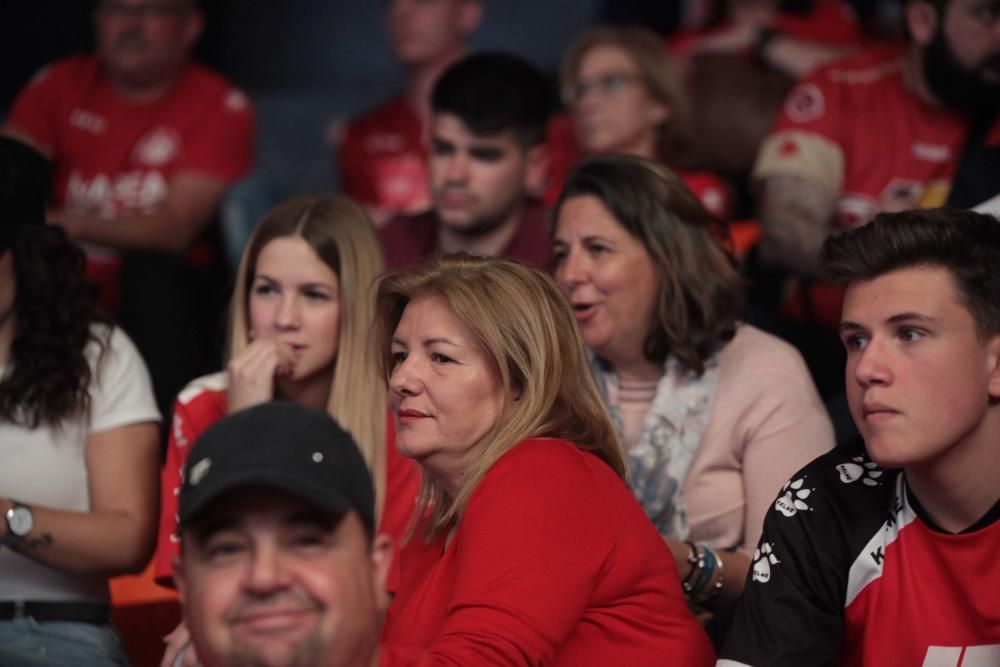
[754,0,1000,327]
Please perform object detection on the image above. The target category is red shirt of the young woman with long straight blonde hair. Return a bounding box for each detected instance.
[154,372,420,592]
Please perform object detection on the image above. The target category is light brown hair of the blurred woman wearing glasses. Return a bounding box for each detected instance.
[559,26,693,162]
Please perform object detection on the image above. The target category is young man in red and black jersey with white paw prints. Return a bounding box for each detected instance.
[718,209,1000,667]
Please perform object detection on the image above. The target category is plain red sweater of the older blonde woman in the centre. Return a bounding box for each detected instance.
[383,439,715,667]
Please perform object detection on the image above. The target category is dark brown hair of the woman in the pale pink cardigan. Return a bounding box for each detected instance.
[552,155,746,375]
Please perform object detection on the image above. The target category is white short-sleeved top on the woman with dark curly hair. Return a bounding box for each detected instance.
[0,325,160,601]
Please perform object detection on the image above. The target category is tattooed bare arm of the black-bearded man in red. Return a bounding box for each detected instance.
[760,174,835,276]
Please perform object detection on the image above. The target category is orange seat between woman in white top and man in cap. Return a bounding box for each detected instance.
[109,563,181,667]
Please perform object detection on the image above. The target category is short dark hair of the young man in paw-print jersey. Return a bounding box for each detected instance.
[820,208,1000,339]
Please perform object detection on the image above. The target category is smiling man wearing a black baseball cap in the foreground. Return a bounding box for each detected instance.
[174,402,392,667]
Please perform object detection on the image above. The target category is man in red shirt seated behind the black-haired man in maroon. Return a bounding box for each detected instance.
[336,0,482,224]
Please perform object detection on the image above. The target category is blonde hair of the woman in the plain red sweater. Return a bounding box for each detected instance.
[375,253,626,540]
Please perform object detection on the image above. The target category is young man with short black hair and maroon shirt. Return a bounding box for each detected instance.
[380,53,554,267]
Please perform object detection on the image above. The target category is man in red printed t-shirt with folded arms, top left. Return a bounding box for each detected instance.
[4,0,254,438]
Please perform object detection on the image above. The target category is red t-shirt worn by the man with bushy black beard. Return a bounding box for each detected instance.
[754,47,996,326]
